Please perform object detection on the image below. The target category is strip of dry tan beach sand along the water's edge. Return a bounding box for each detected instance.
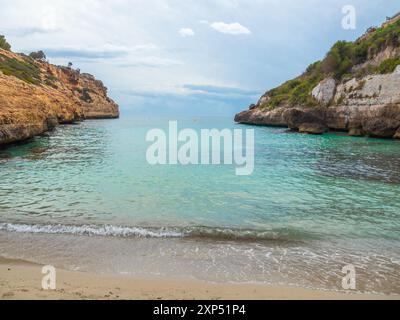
[0,257,400,300]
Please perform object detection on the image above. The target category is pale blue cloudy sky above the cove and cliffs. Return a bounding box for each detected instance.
[0,0,400,116]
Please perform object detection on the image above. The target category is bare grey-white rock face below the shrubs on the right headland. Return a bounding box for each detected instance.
[235,66,400,138]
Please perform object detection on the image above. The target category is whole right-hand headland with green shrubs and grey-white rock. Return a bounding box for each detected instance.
[235,16,400,138]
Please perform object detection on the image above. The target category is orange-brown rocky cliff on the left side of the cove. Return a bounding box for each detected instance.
[0,46,119,146]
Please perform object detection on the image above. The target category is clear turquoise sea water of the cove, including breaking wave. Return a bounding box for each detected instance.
[0,117,400,293]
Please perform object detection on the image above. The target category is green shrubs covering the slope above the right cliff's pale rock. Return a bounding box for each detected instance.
[260,19,400,109]
